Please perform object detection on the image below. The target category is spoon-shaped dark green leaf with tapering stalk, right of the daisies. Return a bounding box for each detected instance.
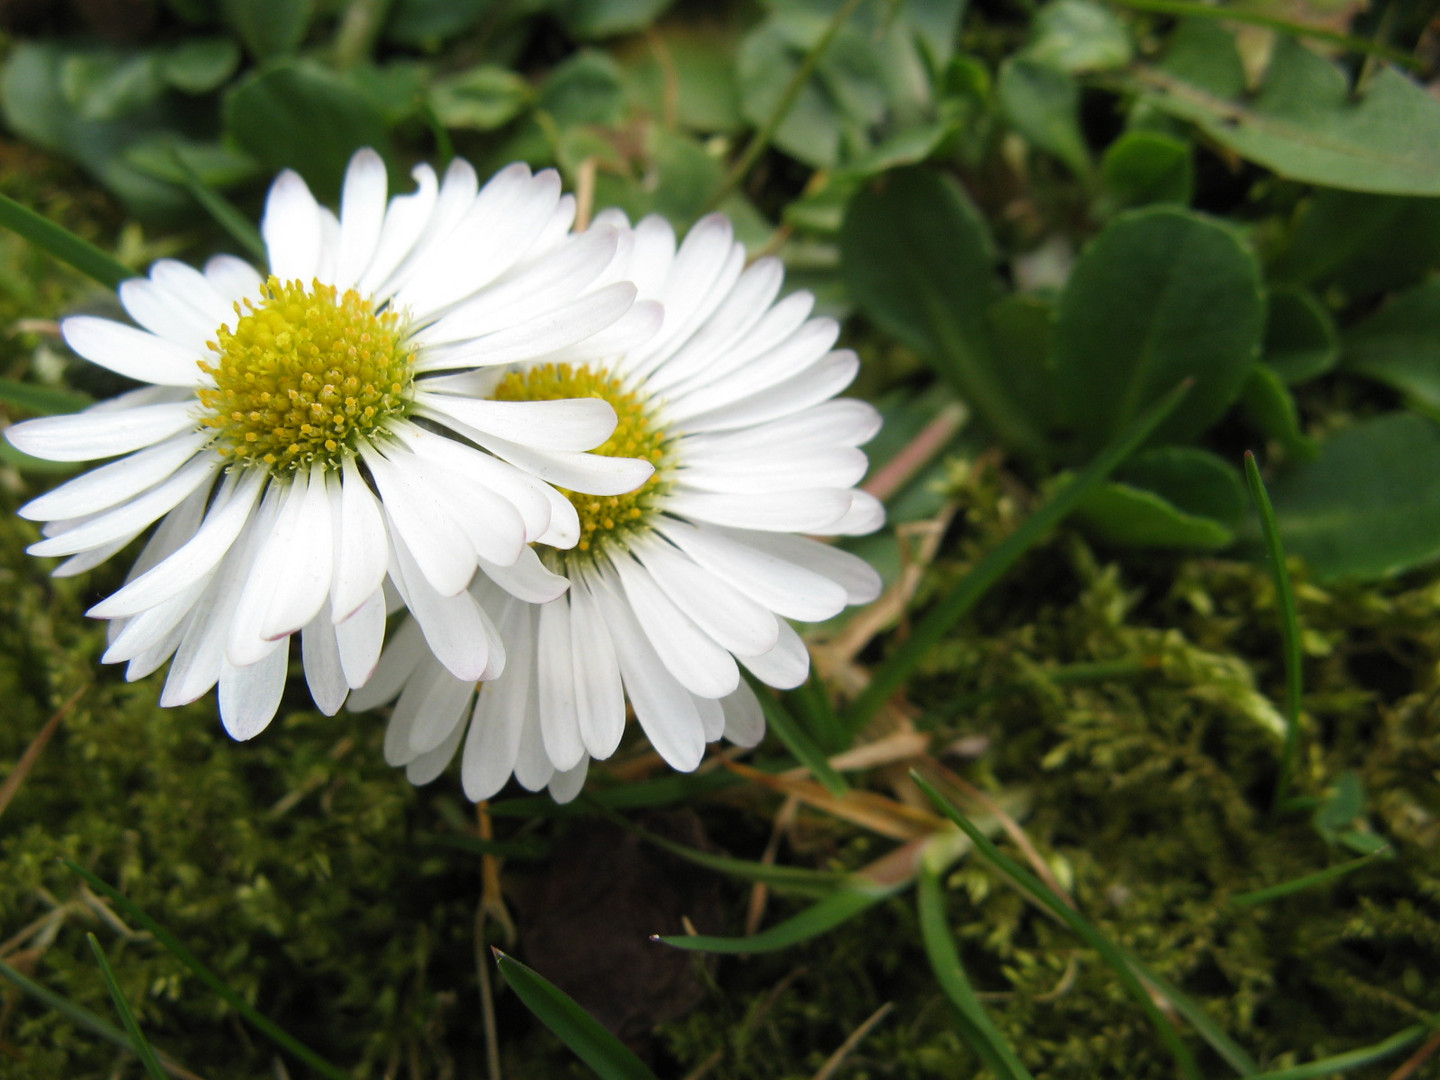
[840,167,1045,452]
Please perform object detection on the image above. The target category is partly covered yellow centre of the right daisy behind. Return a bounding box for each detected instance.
[494,364,670,553]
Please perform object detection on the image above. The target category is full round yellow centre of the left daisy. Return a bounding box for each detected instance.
[199,276,415,474]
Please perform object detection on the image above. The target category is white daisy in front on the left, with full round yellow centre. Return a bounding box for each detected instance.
[6,151,660,739]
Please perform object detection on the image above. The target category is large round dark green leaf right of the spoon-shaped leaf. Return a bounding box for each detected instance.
[1056,207,1264,454]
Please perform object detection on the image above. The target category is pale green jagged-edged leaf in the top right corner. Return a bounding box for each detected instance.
[1142,20,1440,196]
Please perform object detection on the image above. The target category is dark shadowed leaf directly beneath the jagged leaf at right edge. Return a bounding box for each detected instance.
[1273,190,1440,298]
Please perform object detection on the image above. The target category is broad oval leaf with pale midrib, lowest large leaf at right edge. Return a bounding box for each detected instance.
[1270,413,1440,582]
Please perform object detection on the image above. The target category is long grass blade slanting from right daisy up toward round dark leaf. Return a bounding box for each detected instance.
[845,380,1189,736]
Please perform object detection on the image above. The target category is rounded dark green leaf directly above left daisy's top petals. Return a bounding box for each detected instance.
[223,59,390,200]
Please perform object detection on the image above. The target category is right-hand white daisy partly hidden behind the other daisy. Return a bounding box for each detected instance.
[351,213,884,801]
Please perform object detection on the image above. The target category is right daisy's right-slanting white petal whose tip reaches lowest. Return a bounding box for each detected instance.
[595,580,706,772]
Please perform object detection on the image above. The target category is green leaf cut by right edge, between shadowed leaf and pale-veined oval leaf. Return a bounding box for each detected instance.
[1342,279,1440,415]
